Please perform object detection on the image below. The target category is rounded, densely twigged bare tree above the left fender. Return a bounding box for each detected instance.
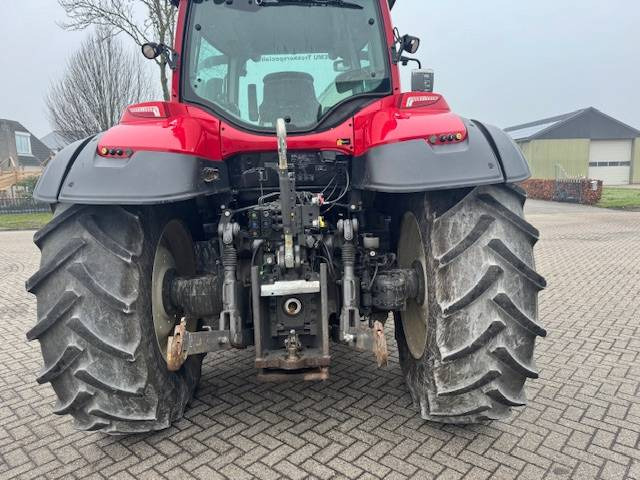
[45,28,152,141]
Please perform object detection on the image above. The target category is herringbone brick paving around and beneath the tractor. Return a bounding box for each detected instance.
[0,202,640,480]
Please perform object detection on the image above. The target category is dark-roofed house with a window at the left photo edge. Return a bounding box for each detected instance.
[0,119,53,172]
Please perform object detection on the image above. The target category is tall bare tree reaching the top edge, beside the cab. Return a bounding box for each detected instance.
[58,0,176,100]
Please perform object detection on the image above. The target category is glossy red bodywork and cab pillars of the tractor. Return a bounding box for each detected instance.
[98,0,467,160]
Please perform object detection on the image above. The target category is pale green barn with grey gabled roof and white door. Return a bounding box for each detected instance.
[505,107,640,185]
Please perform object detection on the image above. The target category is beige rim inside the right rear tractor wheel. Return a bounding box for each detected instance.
[398,212,429,359]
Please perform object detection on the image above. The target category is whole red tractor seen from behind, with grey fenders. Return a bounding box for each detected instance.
[27,0,545,433]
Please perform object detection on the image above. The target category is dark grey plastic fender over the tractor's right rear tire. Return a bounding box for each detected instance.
[353,120,531,193]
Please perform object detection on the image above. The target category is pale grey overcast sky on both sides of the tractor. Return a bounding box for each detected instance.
[0,0,640,136]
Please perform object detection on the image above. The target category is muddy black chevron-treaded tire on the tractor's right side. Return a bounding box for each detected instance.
[396,185,546,423]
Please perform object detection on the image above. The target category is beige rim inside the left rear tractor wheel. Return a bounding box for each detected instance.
[151,220,195,360]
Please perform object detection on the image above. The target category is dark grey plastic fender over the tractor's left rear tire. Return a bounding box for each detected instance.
[34,135,229,205]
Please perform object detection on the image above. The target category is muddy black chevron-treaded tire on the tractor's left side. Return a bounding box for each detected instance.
[27,205,202,433]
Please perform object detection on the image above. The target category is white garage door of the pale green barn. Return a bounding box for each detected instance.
[589,140,631,185]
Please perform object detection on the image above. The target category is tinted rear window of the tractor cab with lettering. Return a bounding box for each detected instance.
[182,0,391,131]
